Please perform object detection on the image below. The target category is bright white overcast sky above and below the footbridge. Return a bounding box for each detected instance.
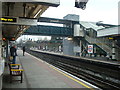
[16,0,120,40]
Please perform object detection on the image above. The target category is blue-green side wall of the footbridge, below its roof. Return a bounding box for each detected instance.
[23,25,73,36]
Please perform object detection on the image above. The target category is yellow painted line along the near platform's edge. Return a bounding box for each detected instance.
[50,66,94,90]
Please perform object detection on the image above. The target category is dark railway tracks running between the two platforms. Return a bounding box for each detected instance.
[28,50,120,90]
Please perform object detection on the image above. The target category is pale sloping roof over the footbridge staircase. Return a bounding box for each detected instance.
[80,21,105,31]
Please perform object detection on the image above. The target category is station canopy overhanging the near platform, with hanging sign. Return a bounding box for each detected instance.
[0,0,60,39]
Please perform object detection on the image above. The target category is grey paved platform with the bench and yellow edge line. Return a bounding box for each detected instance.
[3,50,97,90]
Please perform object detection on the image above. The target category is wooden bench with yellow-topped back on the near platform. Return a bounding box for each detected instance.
[8,64,23,83]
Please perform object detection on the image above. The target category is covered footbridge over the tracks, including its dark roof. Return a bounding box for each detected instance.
[23,17,79,36]
